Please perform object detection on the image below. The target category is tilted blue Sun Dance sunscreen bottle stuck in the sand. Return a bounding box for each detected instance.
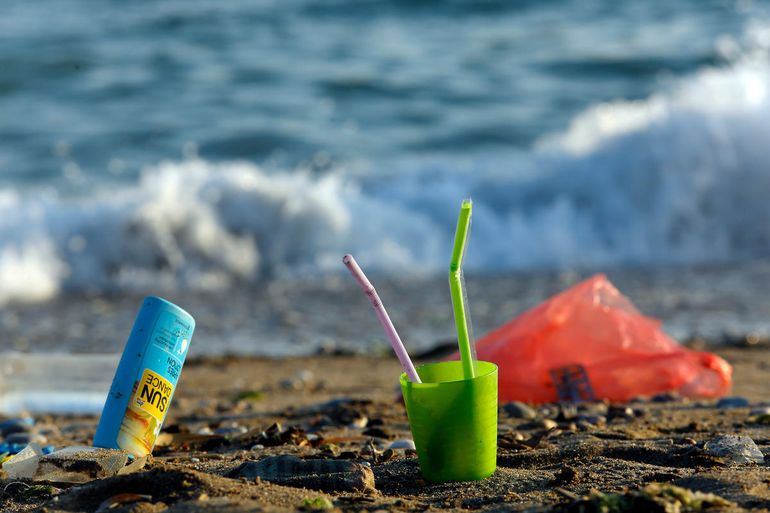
[94,296,195,457]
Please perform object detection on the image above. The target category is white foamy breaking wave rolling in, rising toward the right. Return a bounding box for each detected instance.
[0,37,770,302]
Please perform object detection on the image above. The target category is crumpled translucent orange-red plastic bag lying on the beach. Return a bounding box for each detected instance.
[464,274,732,403]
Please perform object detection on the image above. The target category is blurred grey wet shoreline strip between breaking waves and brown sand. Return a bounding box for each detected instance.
[0,260,770,357]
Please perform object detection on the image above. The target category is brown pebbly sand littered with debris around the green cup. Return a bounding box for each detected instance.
[0,345,770,513]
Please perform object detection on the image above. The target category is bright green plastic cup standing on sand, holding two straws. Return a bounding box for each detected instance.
[401,361,497,483]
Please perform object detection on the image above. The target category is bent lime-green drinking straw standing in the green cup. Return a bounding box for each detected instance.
[449,199,476,379]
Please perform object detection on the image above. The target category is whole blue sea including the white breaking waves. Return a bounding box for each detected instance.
[0,0,770,302]
